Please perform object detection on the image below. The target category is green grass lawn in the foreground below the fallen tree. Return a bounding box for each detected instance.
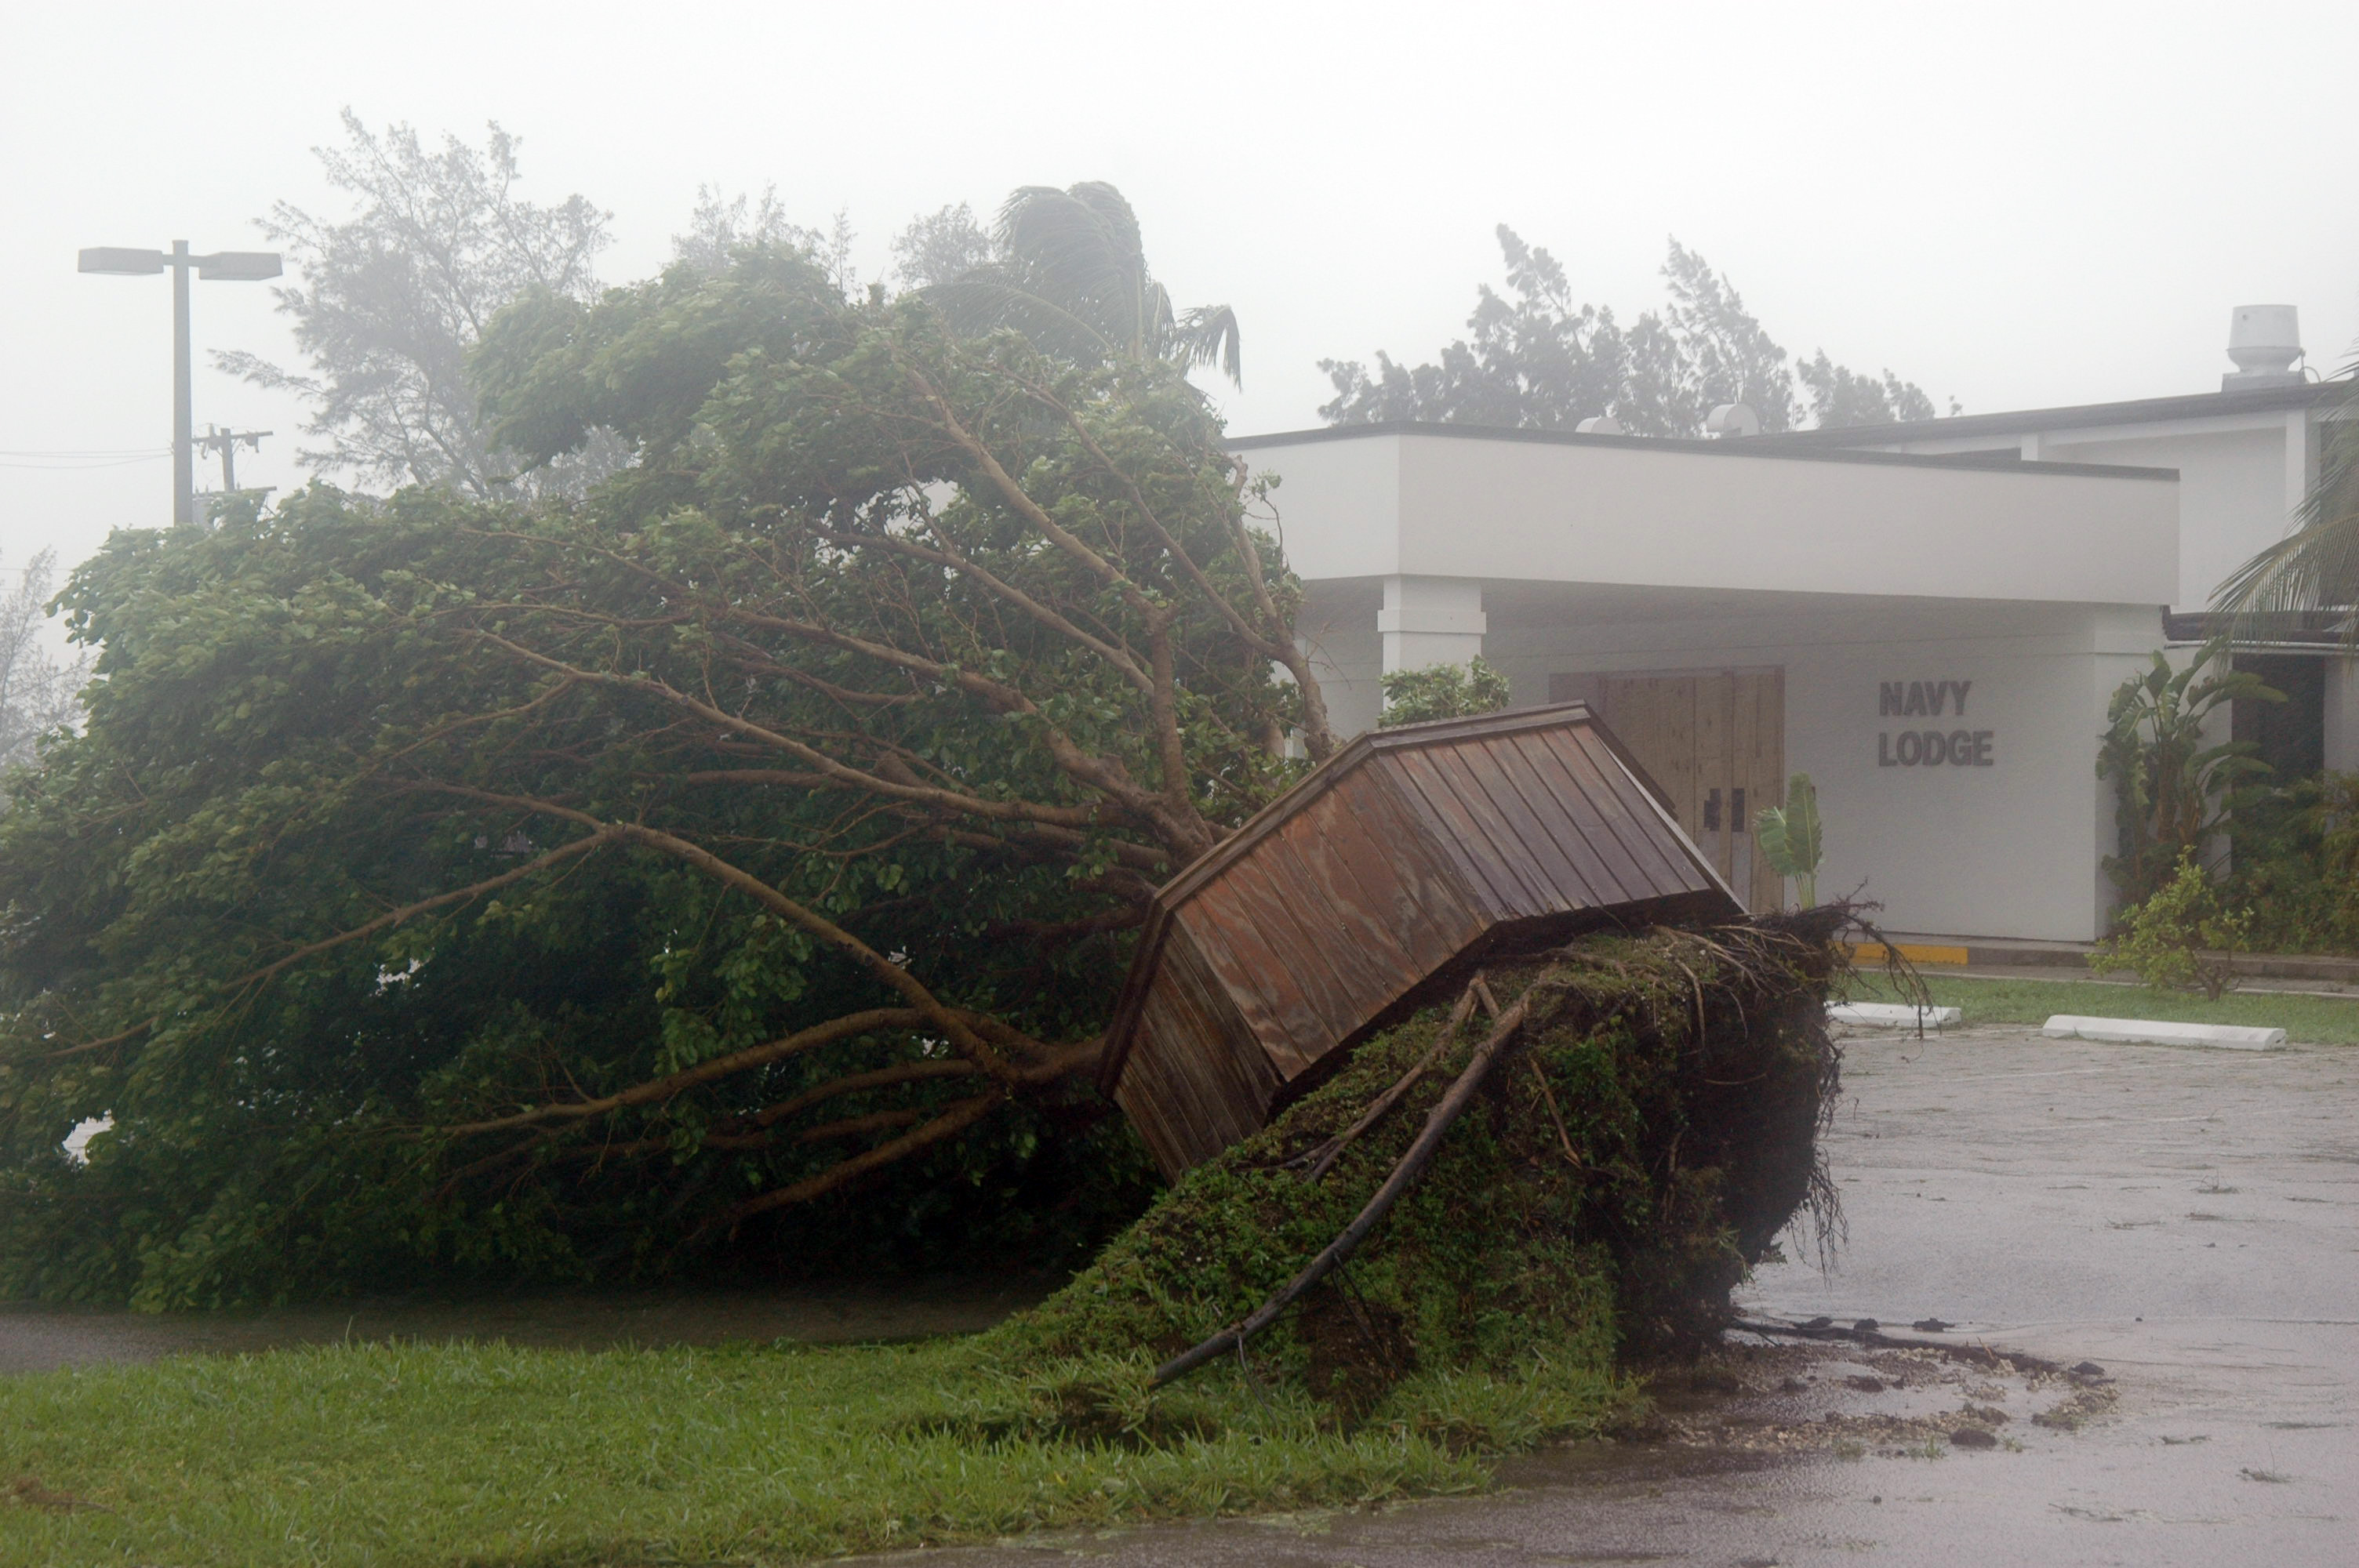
[0,1339,1628,1568]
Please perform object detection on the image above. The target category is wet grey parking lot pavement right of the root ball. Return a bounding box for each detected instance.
[880,1028,2359,1568]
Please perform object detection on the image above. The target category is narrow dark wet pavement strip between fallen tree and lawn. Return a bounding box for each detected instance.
[0,1278,1055,1374]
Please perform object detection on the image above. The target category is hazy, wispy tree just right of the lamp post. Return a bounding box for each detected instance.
[215,108,616,495]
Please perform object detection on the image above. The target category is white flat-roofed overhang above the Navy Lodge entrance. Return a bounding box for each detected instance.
[1231,424,2179,604]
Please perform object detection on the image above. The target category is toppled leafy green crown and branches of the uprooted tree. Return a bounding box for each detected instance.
[0,250,1333,1304]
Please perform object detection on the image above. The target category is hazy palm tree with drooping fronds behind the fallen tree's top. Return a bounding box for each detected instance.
[925,180,1245,387]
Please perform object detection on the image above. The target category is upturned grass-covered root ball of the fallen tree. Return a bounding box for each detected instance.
[976,910,1847,1446]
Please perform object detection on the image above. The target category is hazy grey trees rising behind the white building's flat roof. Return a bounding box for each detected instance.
[1318,224,1956,436]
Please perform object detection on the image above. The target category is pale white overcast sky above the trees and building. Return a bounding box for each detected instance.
[0,0,2359,598]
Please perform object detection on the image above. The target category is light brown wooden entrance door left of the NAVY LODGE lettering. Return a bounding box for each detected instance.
[1547,670,1786,910]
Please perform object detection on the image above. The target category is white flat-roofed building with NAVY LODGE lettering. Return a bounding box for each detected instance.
[1234,310,2359,941]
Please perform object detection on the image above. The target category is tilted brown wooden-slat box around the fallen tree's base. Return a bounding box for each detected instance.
[1100,702,1743,1177]
